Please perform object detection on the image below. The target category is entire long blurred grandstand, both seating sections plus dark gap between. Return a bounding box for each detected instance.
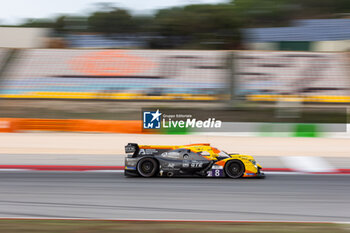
[0,49,350,103]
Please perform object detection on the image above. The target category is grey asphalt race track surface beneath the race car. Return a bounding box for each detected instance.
[0,171,350,222]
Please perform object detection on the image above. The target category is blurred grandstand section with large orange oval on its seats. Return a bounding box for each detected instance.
[0,49,229,100]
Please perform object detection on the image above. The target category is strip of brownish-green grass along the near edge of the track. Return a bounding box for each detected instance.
[0,220,350,233]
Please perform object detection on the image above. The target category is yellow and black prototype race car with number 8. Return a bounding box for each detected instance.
[124,143,265,179]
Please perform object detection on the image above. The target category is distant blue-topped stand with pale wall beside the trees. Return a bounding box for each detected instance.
[243,19,350,51]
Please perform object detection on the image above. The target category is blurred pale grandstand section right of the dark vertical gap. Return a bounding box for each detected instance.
[235,51,350,103]
